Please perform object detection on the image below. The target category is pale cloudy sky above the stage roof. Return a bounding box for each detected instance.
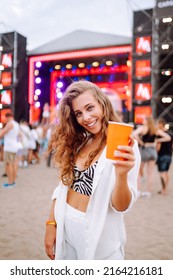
[0,0,155,50]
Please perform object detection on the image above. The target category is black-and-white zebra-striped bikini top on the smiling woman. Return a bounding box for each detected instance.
[71,161,98,196]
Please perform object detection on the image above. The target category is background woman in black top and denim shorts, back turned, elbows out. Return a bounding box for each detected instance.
[132,116,171,197]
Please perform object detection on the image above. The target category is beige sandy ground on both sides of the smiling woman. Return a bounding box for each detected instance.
[0,160,173,260]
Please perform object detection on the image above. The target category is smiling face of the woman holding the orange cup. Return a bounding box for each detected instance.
[72,90,103,135]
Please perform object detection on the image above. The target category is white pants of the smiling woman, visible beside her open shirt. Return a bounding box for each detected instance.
[64,204,124,260]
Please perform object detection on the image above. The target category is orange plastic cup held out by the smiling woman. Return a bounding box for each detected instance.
[106,122,133,160]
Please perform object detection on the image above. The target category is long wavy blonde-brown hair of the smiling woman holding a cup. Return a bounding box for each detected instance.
[48,81,120,186]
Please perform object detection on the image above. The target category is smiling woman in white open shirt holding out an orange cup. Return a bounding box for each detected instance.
[45,81,140,260]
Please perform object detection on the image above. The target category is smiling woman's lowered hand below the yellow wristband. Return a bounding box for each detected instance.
[44,225,56,260]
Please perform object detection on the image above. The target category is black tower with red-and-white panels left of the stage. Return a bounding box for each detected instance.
[0,32,29,121]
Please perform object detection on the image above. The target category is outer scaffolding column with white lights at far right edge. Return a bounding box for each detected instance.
[152,5,173,129]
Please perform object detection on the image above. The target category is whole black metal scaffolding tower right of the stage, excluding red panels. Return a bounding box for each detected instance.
[132,1,173,130]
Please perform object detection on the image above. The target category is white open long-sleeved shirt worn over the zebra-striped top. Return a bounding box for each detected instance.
[52,141,141,260]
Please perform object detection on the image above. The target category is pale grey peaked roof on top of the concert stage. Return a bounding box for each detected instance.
[28,30,132,56]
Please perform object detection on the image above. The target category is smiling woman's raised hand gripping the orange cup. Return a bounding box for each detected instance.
[114,136,135,175]
